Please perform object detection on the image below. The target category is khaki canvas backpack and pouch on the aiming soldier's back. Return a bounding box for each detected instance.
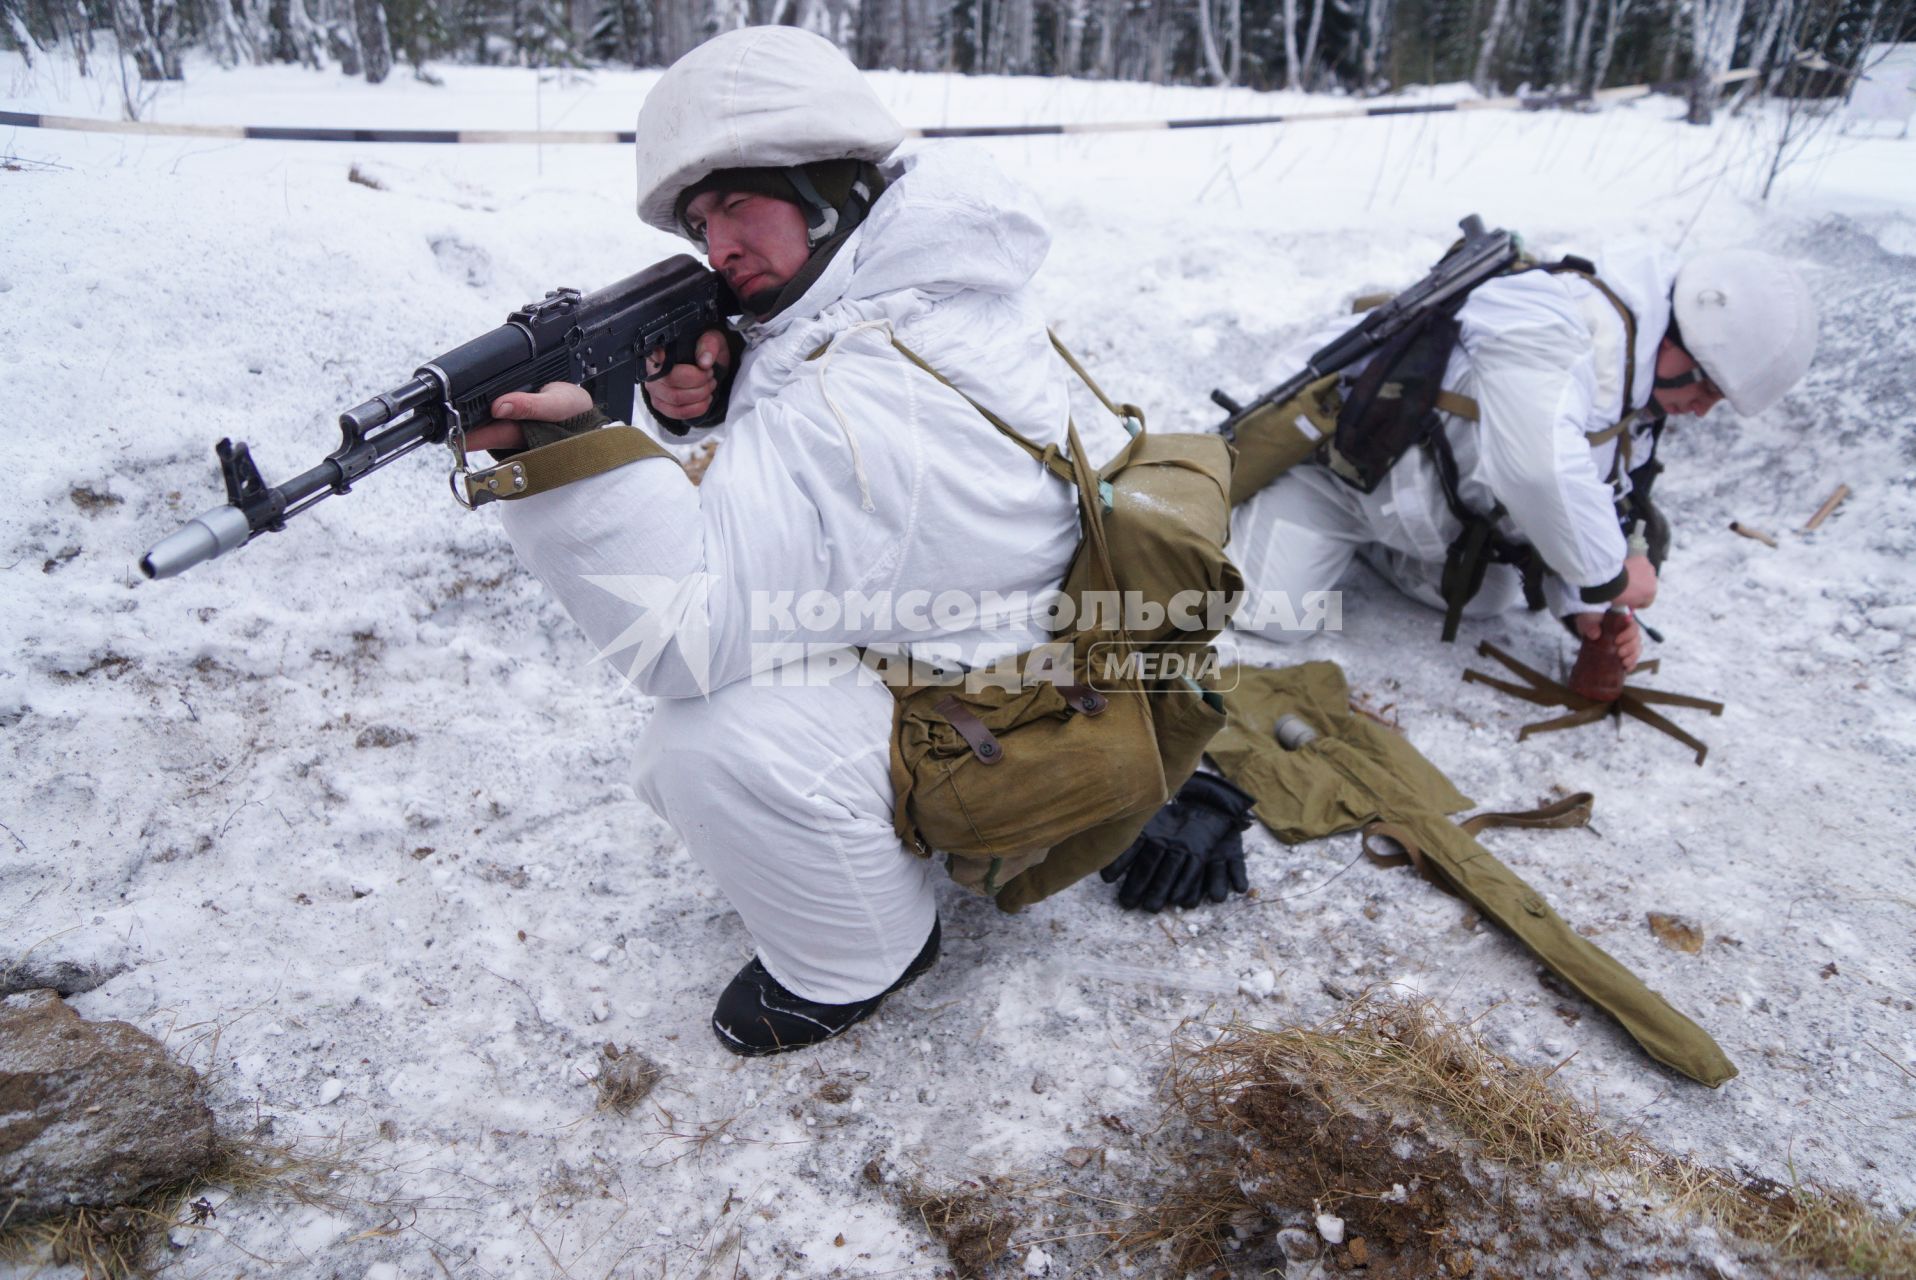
[891,337,1243,912]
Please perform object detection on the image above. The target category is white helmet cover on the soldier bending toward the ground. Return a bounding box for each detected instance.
[1671,249,1816,416]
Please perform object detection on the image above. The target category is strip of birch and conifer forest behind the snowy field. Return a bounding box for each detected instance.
[0,0,1916,121]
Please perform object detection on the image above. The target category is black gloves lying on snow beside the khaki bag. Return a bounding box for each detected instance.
[1100,774,1257,912]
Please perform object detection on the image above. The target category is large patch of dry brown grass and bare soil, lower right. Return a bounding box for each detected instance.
[1123,993,1916,1276]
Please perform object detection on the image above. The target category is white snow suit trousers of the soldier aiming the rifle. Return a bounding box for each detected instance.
[638,663,937,1004]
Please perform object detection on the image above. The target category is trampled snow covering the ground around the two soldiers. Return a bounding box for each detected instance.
[11,56,1916,1278]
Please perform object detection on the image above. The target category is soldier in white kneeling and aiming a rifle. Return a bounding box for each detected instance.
[471,27,1079,1054]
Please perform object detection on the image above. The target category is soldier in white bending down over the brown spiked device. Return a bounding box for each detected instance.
[1232,247,1816,669]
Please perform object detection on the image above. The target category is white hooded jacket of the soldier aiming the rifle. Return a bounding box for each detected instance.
[498,148,1079,697]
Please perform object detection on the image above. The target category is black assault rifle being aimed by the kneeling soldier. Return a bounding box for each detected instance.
[140,253,738,579]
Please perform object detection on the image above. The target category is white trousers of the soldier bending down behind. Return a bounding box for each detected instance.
[1230,466,1523,642]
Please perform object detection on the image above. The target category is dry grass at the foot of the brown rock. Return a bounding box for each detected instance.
[0,1140,354,1280]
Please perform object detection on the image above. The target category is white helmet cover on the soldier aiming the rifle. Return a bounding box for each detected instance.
[638,27,904,234]
